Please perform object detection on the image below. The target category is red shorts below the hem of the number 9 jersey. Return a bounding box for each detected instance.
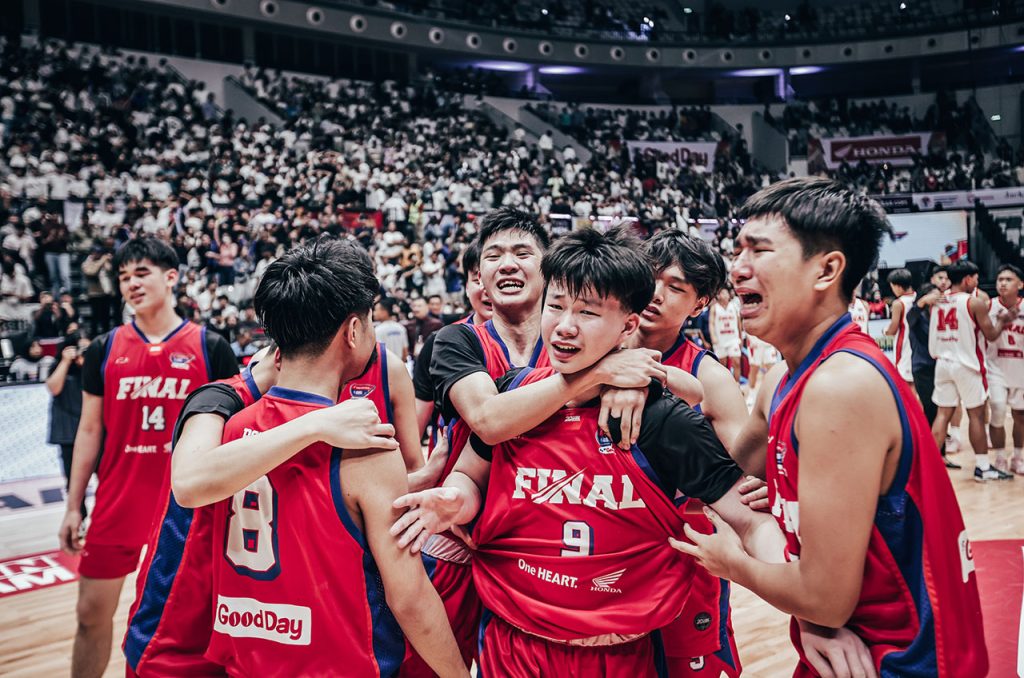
[479,612,665,678]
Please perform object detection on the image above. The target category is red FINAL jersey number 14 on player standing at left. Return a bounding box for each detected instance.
[86,321,210,547]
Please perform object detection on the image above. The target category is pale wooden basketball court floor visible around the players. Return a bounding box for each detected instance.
[0,454,1024,678]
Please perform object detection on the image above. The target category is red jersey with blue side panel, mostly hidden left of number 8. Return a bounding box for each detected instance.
[123,367,260,677]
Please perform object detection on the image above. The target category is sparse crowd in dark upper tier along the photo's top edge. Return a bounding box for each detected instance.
[361,0,1024,43]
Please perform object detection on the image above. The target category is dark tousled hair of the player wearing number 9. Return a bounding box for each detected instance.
[541,228,654,313]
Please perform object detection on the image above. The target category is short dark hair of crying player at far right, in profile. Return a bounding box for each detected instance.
[740,177,892,300]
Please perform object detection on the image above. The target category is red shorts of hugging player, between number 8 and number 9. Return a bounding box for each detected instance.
[398,554,483,678]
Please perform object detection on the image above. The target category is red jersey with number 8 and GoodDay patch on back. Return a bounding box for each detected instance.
[206,374,404,676]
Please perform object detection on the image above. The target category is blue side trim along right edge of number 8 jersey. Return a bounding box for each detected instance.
[329,448,406,677]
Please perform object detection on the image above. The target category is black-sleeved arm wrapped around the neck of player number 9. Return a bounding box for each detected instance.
[430,325,665,444]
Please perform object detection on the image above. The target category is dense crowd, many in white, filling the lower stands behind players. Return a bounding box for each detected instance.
[0,33,1021,383]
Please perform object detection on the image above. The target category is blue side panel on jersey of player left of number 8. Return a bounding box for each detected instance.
[124,493,193,671]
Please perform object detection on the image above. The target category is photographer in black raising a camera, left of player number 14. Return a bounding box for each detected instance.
[46,334,89,518]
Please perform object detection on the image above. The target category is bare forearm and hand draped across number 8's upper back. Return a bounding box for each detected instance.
[171,398,398,508]
